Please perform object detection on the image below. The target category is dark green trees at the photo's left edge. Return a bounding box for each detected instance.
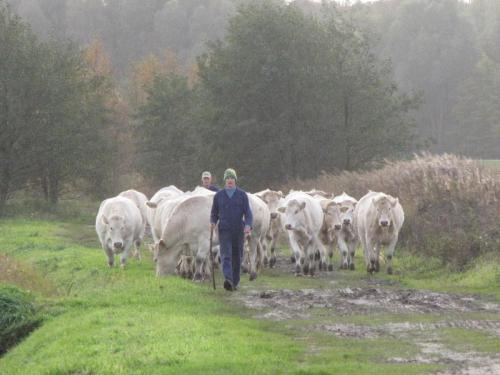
[0,1,116,214]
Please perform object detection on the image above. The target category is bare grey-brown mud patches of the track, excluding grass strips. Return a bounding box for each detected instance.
[231,257,500,375]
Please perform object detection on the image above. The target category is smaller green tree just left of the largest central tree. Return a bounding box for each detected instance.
[135,74,199,188]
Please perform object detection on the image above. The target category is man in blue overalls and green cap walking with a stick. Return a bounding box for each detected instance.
[210,168,253,291]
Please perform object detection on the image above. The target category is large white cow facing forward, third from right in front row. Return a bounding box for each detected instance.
[278,191,326,275]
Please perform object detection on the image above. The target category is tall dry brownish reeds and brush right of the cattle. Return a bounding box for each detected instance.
[284,154,500,269]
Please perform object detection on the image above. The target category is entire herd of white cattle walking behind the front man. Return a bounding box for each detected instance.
[96,185,404,280]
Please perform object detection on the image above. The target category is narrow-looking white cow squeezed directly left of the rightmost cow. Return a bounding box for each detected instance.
[333,193,358,270]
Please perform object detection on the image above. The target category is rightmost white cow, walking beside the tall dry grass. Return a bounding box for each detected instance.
[354,191,404,274]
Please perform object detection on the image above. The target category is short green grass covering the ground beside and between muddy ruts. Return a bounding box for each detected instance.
[0,218,500,375]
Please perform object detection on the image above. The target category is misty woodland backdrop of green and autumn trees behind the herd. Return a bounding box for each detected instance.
[0,0,500,207]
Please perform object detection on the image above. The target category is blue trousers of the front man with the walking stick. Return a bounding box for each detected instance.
[219,229,244,287]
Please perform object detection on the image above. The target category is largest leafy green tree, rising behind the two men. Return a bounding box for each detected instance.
[199,1,415,189]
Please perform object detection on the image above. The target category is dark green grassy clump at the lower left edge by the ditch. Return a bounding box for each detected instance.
[0,284,41,354]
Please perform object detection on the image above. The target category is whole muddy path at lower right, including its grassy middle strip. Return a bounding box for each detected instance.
[229,256,500,375]
